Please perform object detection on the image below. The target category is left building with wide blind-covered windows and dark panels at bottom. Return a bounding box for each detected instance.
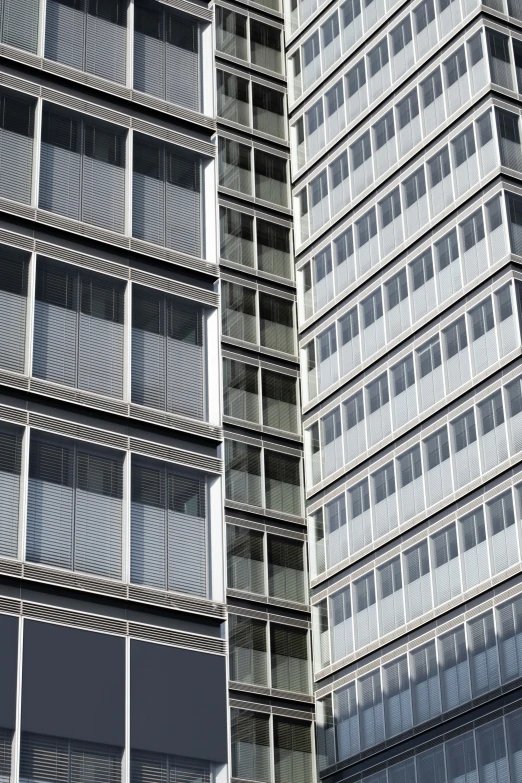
[0,0,229,783]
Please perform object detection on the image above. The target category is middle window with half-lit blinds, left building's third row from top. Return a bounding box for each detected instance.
[33,258,125,397]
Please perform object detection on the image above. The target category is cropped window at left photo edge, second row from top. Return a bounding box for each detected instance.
[0,91,35,204]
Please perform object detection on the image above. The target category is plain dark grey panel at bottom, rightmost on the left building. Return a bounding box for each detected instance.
[130,640,227,762]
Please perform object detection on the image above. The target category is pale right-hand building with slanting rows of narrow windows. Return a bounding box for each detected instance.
[287,0,522,783]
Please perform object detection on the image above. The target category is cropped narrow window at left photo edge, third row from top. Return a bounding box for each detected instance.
[0,245,29,372]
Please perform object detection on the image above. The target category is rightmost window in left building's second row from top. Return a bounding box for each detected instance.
[132,134,203,256]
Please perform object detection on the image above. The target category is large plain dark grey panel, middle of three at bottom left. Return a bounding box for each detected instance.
[22,620,125,747]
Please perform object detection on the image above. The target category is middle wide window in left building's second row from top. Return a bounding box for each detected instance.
[39,104,125,232]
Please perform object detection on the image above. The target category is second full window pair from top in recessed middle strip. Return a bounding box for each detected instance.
[216,69,286,139]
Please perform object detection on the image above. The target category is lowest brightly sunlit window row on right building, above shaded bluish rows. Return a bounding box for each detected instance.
[314,485,522,672]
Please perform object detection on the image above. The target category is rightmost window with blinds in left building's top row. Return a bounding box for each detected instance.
[134,0,201,111]
